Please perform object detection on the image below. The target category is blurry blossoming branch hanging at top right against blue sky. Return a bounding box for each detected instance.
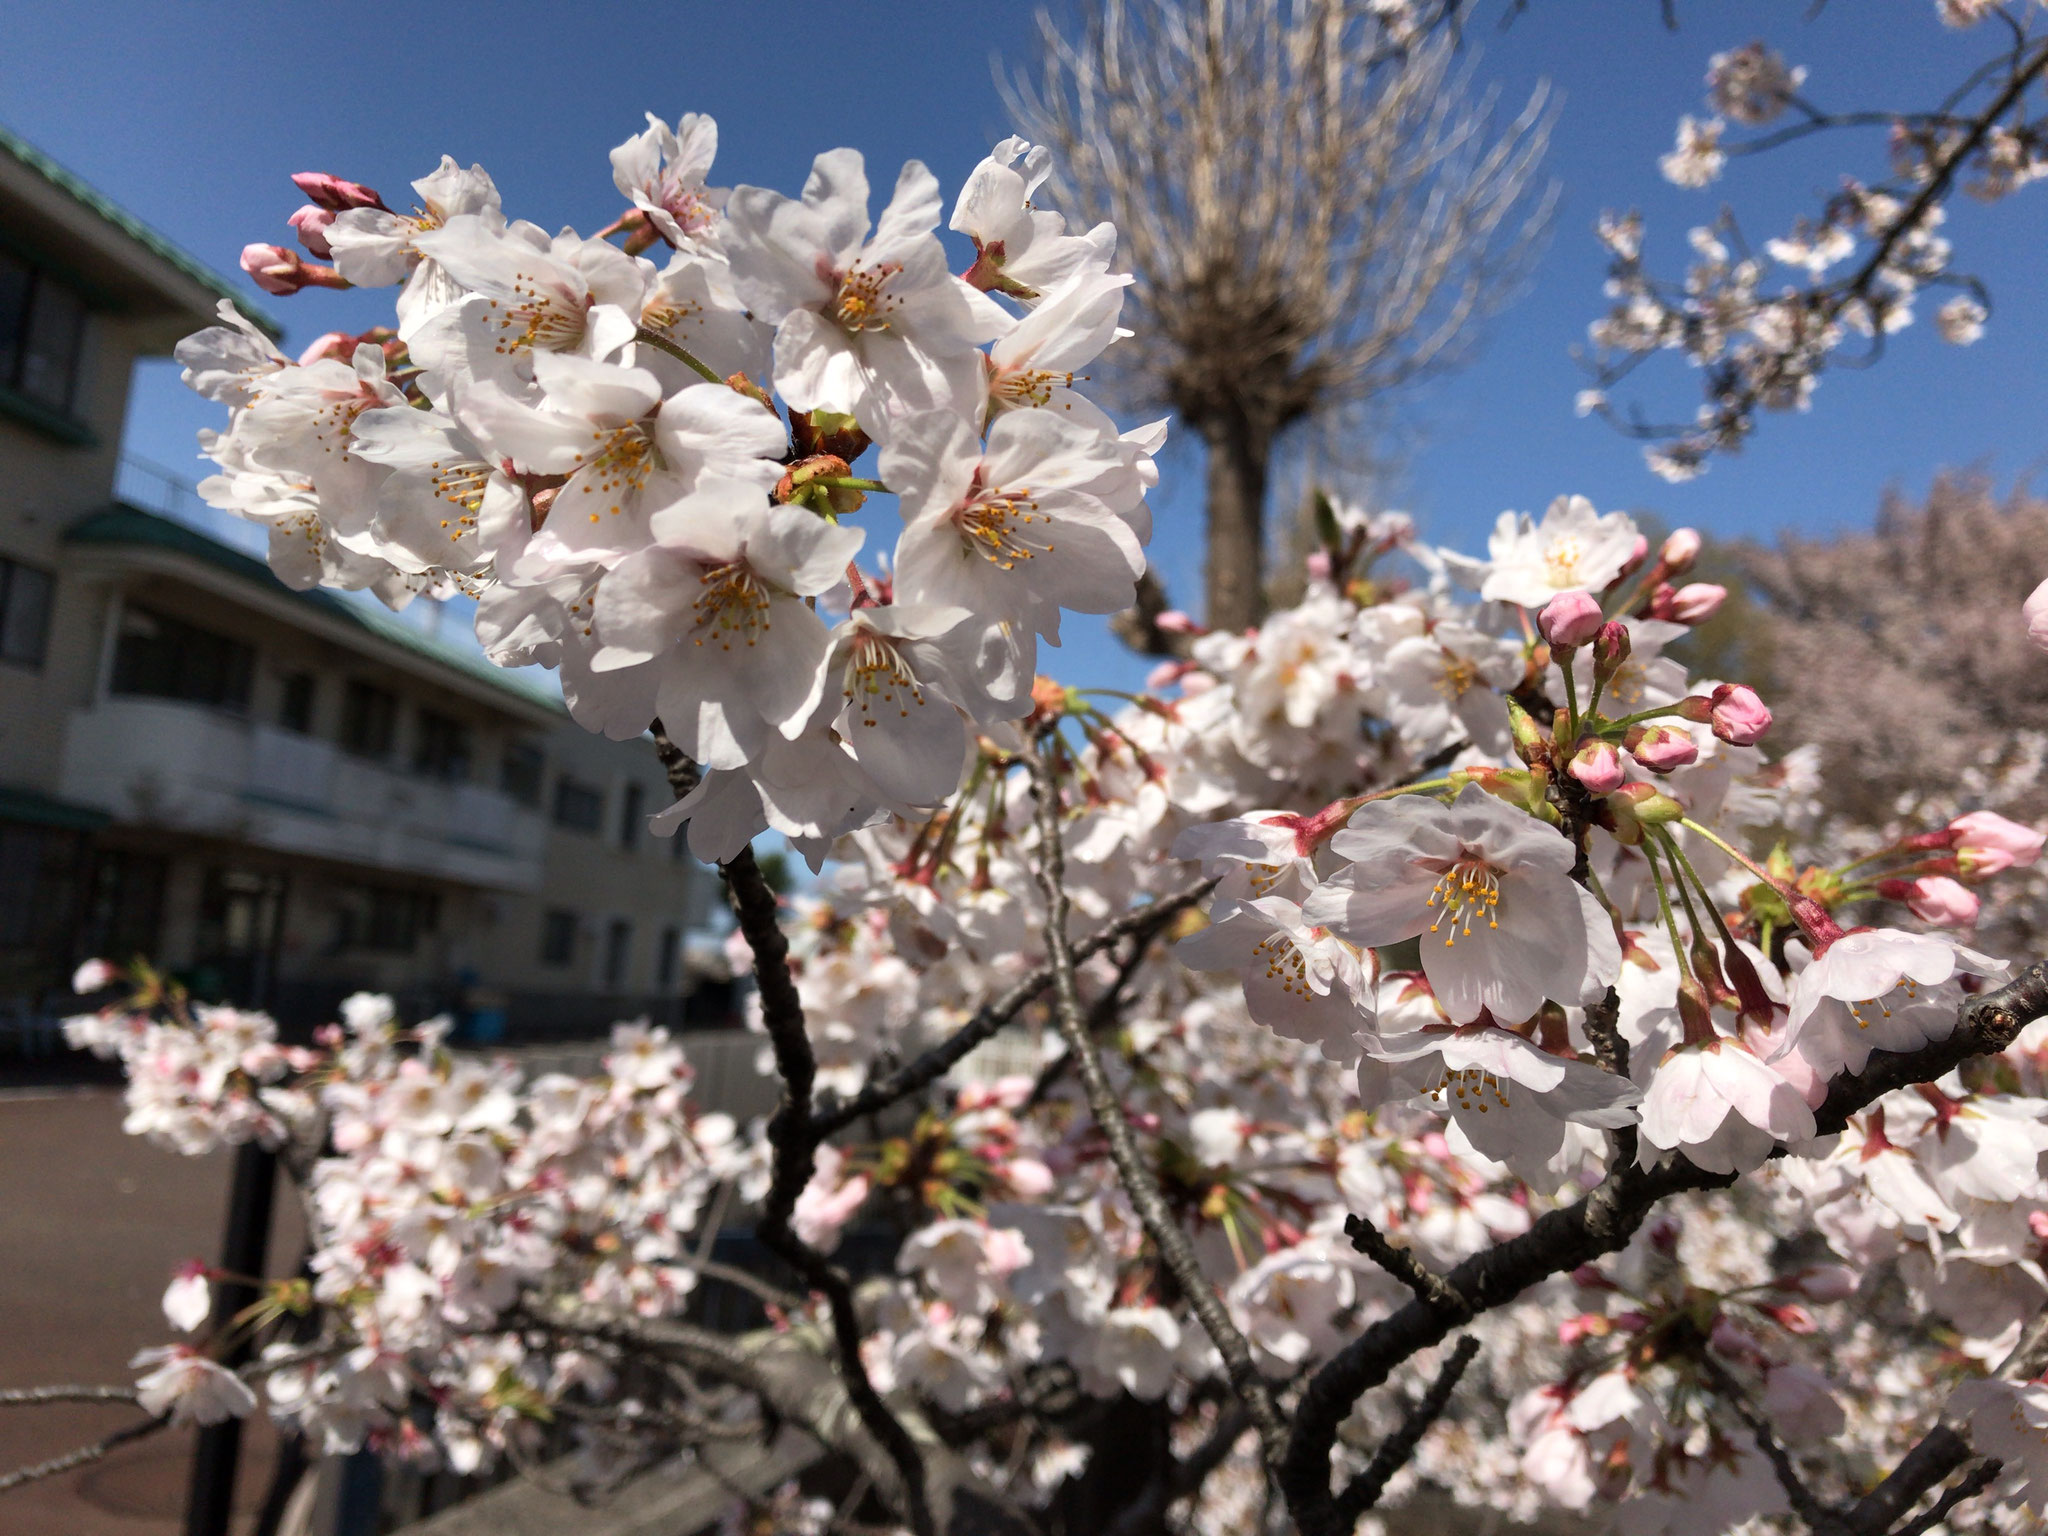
[1579,0,2048,481]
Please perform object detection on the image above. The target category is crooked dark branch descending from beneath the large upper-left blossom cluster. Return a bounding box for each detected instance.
[721,848,938,1536]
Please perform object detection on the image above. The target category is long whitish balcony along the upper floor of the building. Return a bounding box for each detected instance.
[61,698,547,891]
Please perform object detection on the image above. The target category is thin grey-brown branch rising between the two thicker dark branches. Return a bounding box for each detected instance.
[1026,743,1286,1464]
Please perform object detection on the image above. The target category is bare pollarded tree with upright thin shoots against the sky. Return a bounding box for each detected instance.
[1010,0,1552,629]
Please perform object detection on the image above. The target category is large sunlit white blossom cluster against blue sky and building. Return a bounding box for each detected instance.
[178,115,1165,860]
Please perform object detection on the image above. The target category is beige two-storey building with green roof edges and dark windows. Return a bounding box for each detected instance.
[0,123,727,1038]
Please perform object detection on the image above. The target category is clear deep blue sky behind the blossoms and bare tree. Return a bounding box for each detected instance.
[0,0,2048,682]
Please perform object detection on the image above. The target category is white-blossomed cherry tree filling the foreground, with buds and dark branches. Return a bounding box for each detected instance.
[19,3,2048,1536]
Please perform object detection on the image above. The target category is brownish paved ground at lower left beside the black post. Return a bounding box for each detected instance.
[0,1087,299,1536]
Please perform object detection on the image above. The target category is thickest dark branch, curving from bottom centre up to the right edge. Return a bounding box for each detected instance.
[1280,965,2048,1536]
